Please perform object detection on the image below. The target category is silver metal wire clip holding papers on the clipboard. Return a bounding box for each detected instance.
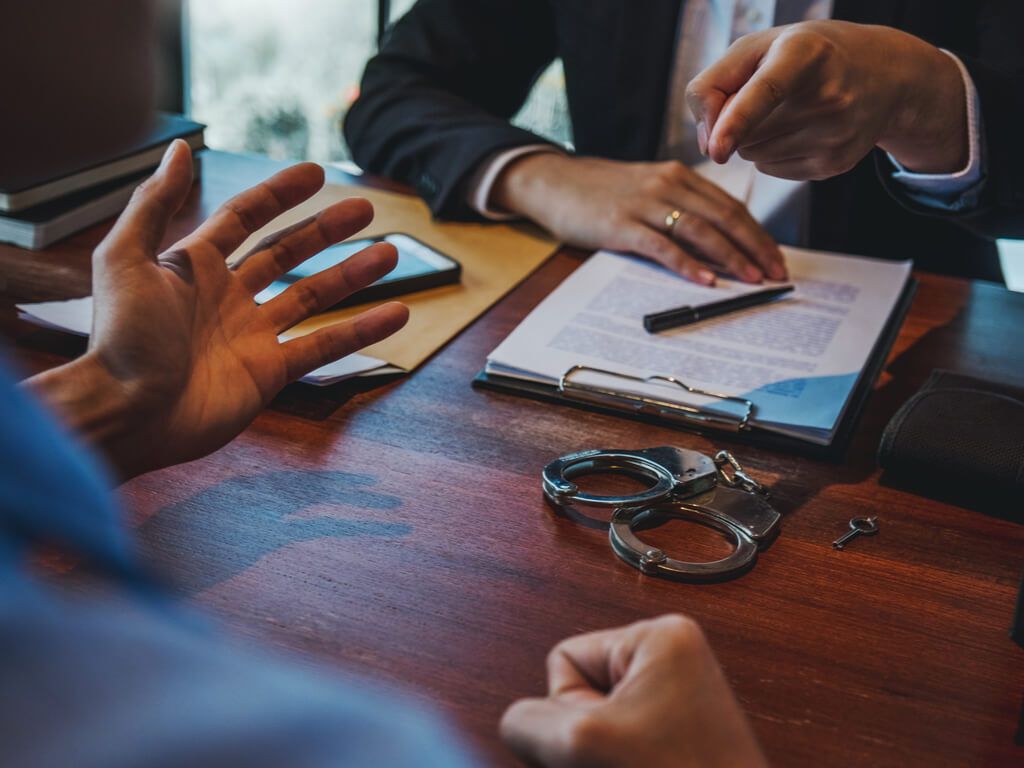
[558,366,755,432]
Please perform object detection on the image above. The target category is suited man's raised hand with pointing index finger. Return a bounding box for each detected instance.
[687,20,969,179]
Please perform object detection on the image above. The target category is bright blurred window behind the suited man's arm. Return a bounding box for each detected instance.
[185,0,570,163]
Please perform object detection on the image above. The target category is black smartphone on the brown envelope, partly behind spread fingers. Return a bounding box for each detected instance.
[256,232,462,309]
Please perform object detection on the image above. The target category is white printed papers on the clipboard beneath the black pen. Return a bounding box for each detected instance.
[486,248,911,444]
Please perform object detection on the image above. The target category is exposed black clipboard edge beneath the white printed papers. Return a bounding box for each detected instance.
[473,276,918,461]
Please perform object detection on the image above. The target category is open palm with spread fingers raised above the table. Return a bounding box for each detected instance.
[28,141,409,479]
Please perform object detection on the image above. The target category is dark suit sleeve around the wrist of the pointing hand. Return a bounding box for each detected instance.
[878,0,1024,239]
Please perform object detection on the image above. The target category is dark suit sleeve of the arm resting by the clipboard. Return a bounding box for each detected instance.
[344,0,556,219]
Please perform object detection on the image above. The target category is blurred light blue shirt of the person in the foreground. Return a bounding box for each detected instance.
[0,361,472,768]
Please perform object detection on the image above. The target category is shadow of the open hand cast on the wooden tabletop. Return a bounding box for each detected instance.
[137,470,413,595]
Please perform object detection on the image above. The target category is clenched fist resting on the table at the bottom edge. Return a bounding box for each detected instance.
[502,615,767,768]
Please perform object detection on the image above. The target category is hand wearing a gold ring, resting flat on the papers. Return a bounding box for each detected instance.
[490,152,785,285]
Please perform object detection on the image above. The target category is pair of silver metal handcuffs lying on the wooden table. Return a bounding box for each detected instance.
[542,446,781,582]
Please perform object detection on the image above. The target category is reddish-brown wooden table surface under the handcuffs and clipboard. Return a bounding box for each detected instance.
[0,154,1024,767]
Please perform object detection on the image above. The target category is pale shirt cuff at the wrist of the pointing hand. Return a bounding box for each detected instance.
[887,50,982,210]
